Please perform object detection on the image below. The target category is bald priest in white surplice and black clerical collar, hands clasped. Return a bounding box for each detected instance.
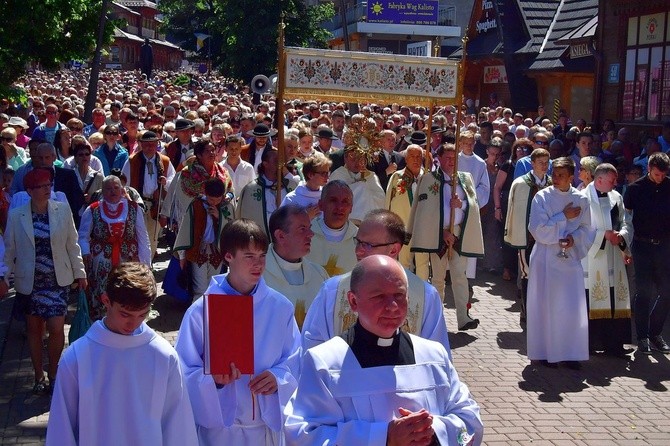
[284,255,483,446]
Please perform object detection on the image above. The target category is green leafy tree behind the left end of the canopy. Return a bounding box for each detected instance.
[159,0,335,82]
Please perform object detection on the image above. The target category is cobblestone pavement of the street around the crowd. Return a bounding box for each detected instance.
[0,246,670,446]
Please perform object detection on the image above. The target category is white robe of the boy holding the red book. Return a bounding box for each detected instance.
[175,275,300,446]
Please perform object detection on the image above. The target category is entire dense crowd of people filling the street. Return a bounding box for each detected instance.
[0,71,670,445]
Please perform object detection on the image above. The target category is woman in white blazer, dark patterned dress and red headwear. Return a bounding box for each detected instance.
[5,168,87,393]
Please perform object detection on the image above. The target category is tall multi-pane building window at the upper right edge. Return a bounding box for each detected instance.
[621,12,670,121]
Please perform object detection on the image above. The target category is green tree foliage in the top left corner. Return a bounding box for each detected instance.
[0,0,113,94]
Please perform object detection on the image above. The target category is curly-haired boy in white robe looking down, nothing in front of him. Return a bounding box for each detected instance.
[46,263,198,446]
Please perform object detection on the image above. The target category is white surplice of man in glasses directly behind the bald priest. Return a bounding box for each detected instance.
[302,270,451,358]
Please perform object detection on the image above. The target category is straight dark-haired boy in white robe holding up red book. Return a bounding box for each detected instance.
[176,219,300,446]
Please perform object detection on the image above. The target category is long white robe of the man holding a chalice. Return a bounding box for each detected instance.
[526,186,595,362]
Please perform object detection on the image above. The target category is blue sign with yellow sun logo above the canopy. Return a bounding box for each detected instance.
[367,0,439,25]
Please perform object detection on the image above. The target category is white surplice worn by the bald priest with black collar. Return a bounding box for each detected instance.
[284,335,483,446]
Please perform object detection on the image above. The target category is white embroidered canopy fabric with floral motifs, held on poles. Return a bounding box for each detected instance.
[284,47,458,104]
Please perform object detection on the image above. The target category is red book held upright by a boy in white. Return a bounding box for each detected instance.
[203,294,254,375]
